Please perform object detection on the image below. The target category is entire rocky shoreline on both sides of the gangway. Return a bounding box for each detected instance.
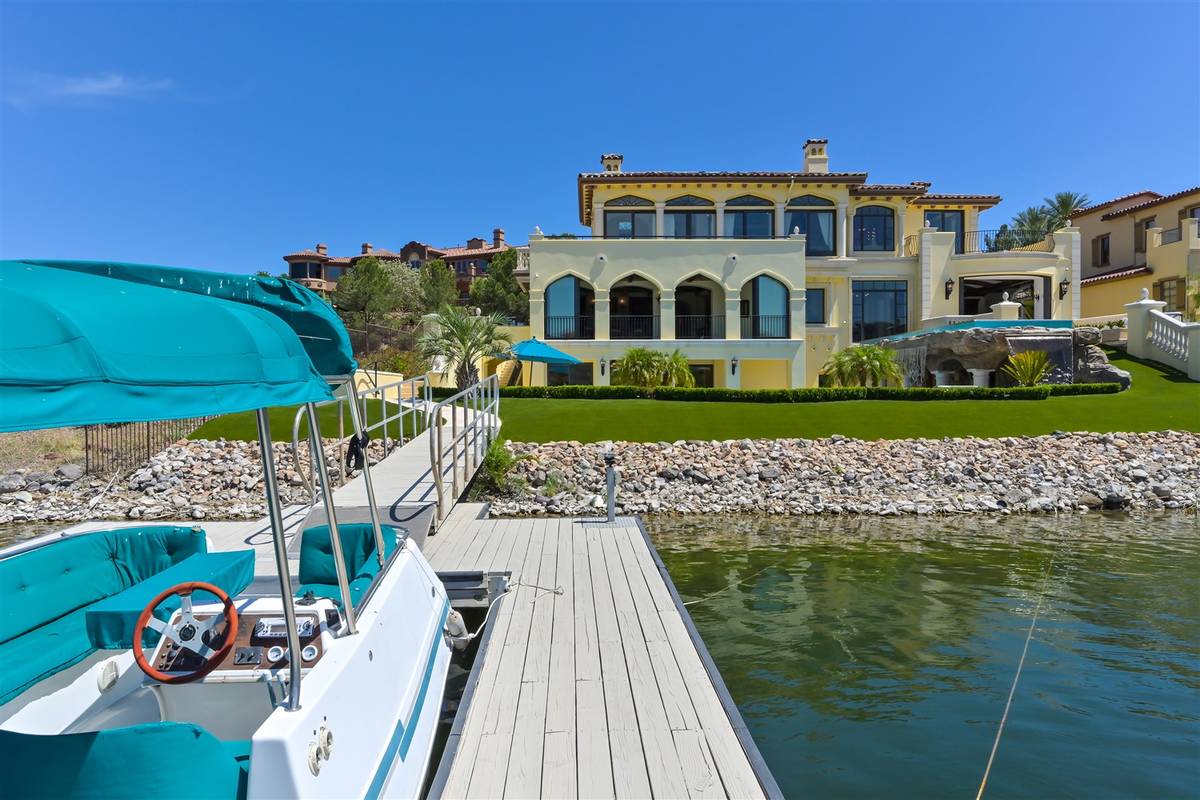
[0,431,1200,524]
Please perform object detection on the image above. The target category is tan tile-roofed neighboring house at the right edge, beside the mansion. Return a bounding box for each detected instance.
[1070,186,1200,317]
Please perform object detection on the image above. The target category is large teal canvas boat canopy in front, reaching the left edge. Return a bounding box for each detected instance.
[0,261,340,432]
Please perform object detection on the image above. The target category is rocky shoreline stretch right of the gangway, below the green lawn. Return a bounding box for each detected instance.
[488,431,1200,517]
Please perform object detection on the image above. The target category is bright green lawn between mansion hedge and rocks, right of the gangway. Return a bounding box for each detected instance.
[500,353,1200,441]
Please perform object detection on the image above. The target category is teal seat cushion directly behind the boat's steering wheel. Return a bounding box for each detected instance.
[85,551,254,650]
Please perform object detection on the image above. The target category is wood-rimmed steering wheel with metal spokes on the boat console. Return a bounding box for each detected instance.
[133,581,238,684]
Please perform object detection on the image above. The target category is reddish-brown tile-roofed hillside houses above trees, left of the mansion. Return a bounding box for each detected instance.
[283,228,512,297]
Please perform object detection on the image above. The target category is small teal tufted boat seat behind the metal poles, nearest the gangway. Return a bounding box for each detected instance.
[296,523,397,608]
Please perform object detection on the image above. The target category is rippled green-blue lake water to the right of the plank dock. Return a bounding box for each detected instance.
[648,515,1200,798]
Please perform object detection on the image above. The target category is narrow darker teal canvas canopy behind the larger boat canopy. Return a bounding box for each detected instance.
[24,260,358,377]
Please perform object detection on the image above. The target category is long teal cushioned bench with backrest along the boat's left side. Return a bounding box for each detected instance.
[0,525,253,705]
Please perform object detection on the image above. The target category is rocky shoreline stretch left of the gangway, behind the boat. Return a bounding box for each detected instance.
[0,439,384,524]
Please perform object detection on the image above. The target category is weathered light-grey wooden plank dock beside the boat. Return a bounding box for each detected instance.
[424,504,781,798]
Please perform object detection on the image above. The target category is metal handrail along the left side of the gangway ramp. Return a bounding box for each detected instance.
[292,375,433,503]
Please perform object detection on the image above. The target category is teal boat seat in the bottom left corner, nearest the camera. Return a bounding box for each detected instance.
[0,722,250,800]
